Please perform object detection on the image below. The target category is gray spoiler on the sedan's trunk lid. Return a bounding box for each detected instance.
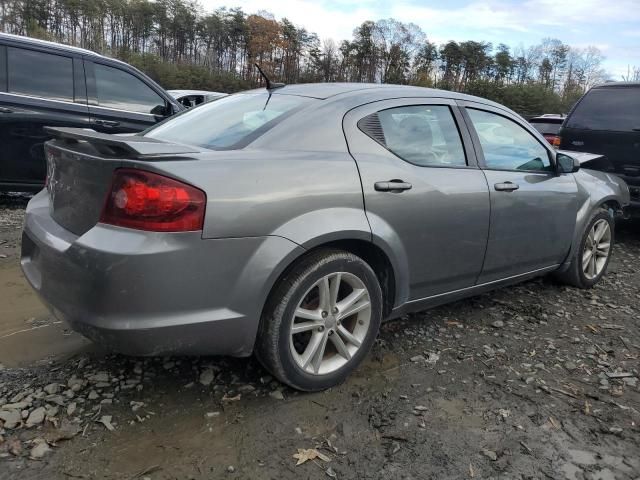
[44,127,200,158]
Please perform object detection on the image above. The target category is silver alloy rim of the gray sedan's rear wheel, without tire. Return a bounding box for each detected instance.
[289,272,371,375]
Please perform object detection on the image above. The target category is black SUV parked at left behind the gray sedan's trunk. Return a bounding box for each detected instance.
[0,34,184,191]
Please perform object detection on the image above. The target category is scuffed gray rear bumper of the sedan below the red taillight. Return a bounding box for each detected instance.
[21,192,302,356]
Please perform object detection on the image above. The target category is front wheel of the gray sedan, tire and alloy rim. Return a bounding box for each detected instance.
[556,209,615,289]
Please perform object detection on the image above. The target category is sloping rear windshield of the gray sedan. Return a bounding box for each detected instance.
[145,92,314,150]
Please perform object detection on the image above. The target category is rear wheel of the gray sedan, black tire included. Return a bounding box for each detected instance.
[256,250,382,391]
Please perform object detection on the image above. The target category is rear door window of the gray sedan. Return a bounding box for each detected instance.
[363,105,467,167]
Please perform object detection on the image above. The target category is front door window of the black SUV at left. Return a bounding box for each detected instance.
[94,63,166,114]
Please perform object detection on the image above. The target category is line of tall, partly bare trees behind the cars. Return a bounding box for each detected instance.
[0,0,620,115]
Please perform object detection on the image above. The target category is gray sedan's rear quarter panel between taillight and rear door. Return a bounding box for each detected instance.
[134,150,371,248]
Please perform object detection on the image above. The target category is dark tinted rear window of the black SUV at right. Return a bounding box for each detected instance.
[566,87,640,132]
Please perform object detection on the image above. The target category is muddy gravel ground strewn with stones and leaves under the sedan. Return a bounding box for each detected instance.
[0,193,640,480]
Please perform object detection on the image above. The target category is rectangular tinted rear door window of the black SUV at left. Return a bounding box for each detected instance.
[7,47,73,102]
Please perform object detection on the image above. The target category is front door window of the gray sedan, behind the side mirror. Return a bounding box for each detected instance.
[467,108,553,172]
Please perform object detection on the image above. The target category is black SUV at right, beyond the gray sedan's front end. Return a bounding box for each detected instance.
[560,82,640,210]
